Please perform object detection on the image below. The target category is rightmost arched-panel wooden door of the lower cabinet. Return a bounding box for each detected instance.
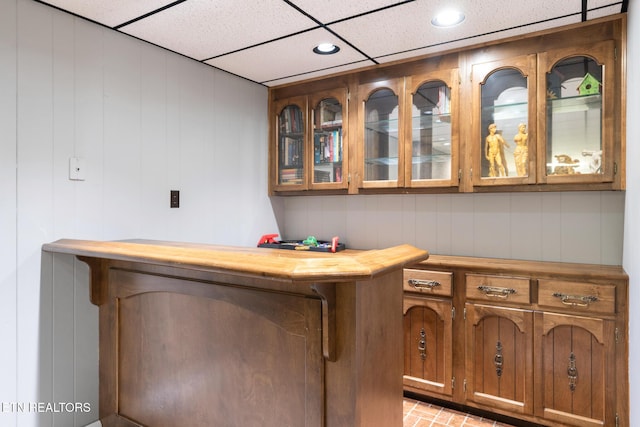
[535,312,616,427]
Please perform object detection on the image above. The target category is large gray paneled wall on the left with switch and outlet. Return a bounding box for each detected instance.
[0,0,278,427]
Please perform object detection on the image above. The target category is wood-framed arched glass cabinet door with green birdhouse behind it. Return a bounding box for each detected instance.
[539,42,614,183]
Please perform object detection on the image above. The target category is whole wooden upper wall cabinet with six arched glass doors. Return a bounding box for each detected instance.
[270,15,626,194]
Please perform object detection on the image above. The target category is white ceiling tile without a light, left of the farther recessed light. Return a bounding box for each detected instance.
[120,0,317,60]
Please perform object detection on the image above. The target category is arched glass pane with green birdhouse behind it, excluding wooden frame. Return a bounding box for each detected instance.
[546,56,603,175]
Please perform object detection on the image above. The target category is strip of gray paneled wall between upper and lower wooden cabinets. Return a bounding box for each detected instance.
[283,191,625,265]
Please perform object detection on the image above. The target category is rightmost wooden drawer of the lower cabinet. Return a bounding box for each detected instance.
[538,279,616,313]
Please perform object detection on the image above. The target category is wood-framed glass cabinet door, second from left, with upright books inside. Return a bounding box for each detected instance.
[310,89,348,189]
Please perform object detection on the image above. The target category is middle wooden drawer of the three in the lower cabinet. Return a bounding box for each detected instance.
[466,274,531,304]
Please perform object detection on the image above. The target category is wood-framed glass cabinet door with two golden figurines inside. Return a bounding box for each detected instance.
[472,55,536,185]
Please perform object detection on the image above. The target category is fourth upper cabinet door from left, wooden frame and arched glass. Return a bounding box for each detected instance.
[405,71,458,187]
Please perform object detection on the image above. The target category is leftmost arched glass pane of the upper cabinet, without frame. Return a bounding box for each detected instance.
[278,105,304,185]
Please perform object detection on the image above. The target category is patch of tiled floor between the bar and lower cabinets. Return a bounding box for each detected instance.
[403,397,524,427]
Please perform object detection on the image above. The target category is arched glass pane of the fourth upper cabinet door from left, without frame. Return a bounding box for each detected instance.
[411,81,451,180]
